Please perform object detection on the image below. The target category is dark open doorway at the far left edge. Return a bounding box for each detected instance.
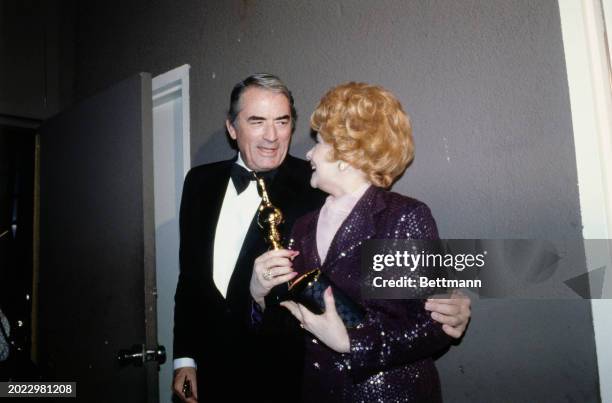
[0,124,37,380]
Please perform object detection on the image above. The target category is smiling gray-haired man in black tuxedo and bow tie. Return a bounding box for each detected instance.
[173,74,470,402]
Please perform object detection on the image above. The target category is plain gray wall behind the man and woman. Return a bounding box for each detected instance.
[70,0,599,402]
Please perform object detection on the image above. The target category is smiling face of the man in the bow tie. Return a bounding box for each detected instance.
[225,87,291,172]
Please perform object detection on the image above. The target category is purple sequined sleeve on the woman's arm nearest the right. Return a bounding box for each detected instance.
[346,204,451,377]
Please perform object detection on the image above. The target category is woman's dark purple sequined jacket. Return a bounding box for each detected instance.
[292,186,450,403]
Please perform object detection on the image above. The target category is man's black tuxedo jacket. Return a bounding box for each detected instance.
[174,155,324,401]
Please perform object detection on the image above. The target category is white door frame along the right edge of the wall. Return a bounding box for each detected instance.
[559,0,612,402]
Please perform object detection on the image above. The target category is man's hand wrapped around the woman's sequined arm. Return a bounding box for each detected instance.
[425,290,472,339]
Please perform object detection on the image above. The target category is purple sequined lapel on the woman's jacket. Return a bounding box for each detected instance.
[323,186,385,267]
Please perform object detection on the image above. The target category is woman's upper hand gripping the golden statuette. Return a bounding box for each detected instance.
[249,249,300,309]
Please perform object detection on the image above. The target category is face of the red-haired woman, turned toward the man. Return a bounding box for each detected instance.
[306,133,341,195]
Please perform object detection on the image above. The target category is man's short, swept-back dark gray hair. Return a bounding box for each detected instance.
[227,73,297,133]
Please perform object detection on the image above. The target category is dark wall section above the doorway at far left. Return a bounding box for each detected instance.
[0,0,74,120]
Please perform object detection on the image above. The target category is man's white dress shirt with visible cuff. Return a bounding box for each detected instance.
[173,153,261,369]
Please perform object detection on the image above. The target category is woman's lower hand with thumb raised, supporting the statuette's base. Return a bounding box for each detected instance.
[281,287,351,353]
